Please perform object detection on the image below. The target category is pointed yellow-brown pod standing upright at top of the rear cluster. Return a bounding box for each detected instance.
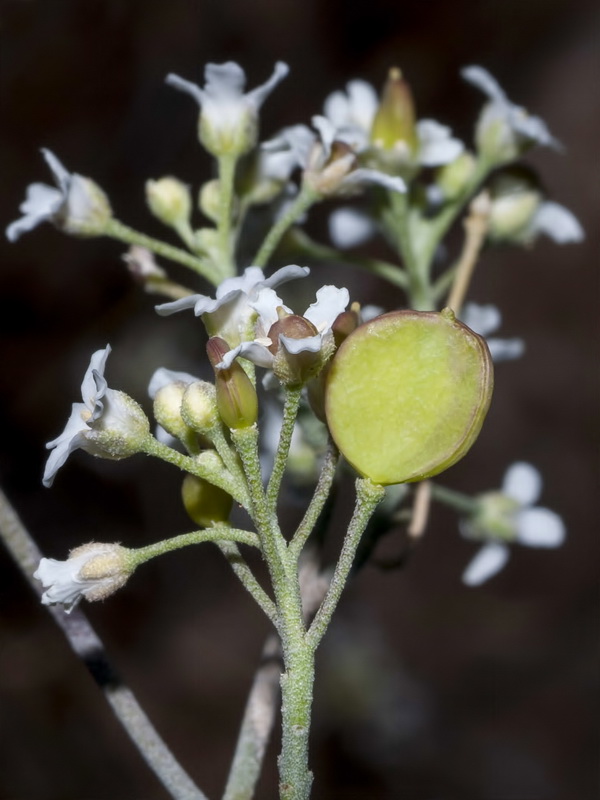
[371,67,419,156]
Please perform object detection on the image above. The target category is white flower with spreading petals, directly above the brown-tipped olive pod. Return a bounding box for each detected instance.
[155,264,310,347]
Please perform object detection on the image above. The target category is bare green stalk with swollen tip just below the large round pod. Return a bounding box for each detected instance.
[306,478,385,649]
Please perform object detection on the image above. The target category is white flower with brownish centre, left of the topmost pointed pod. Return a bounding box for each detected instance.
[263,116,406,197]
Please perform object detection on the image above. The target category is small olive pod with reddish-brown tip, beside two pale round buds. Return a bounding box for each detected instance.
[206,336,258,430]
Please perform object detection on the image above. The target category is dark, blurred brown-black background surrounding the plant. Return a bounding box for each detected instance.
[0,0,600,800]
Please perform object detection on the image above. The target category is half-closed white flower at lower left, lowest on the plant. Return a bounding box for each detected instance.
[33,542,132,614]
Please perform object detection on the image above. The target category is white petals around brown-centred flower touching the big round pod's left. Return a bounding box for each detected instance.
[217,286,350,376]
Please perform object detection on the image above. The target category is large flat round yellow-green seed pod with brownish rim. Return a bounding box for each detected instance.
[325,309,493,485]
